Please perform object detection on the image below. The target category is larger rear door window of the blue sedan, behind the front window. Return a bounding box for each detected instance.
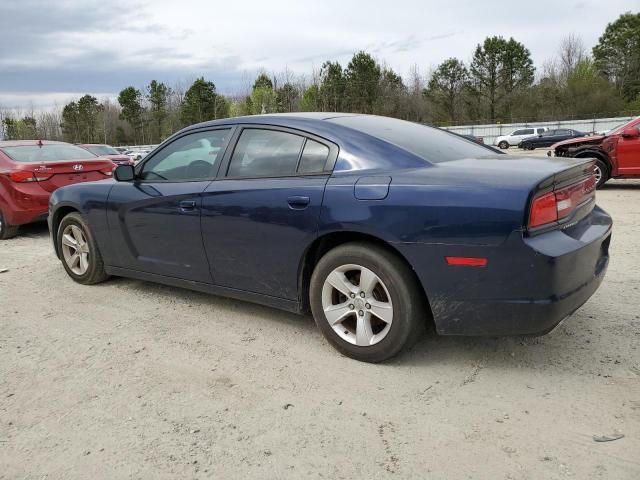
[227,128,304,177]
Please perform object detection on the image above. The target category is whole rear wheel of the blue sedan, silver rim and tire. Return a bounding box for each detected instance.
[309,242,426,363]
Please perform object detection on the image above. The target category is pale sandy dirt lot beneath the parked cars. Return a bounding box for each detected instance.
[0,177,640,480]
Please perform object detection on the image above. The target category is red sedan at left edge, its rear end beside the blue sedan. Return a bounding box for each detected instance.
[0,140,114,240]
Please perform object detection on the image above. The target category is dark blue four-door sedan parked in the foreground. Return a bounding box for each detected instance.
[49,113,611,362]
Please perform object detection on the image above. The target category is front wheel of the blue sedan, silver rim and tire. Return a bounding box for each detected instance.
[56,213,109,285]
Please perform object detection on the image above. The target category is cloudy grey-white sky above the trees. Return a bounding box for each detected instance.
[0,0,640,108]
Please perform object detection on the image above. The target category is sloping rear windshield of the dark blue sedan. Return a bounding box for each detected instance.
[328,115,491,163]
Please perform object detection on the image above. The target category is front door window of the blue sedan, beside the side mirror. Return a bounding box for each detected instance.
[139,129,231,182]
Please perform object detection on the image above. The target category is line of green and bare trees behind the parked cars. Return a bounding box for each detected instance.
[0,13,640,145]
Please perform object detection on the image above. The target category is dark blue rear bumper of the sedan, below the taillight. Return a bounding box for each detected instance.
[398,207,612,336]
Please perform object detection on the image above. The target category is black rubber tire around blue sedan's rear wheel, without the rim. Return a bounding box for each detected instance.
[309,242,428,363]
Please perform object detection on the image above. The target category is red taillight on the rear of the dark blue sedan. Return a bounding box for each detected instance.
[529,175,596,228]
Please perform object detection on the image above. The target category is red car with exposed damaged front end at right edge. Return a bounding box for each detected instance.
[548,117,640,187]
